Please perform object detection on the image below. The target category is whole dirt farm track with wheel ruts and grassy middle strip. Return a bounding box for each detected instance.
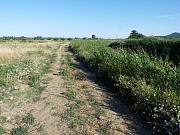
[1,43,150,135]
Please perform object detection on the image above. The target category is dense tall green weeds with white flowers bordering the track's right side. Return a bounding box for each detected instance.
[73,41,180,135]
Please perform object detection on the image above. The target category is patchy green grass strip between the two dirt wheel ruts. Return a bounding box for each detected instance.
[60,48,114,135]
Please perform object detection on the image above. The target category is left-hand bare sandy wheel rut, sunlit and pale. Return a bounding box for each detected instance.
[24,43,70,135]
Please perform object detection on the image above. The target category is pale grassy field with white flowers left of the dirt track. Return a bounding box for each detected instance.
[0,41,59,135]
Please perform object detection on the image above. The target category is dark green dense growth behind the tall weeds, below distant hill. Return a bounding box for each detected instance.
[109,38,180,65]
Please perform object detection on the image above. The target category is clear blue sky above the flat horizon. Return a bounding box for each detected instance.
[0,0,180,38]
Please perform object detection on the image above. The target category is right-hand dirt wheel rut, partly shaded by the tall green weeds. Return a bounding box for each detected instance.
[62,46,151,135]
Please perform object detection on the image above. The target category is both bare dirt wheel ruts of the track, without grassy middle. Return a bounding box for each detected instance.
[0,43,149,135]
